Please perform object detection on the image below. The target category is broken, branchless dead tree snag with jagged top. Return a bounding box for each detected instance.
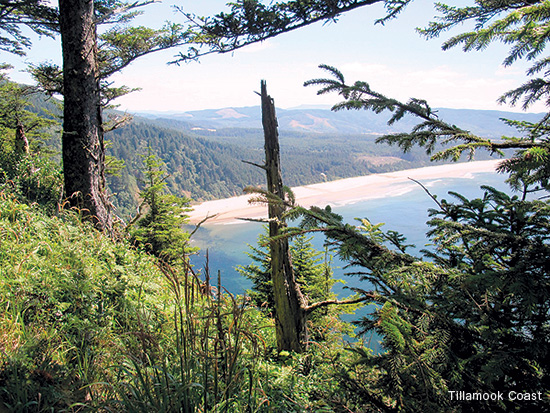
[261,81,307,352]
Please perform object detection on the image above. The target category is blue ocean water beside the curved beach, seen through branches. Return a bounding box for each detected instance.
[192,173,508,353]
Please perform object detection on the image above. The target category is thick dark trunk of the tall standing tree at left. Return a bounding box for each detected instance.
[59,0,112,231]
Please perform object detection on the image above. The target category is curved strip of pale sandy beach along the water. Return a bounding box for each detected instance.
[189,160,500,225]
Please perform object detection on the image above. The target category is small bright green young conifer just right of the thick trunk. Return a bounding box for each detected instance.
[129,150,196,263]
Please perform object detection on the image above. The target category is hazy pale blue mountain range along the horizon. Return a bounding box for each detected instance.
[139,106,541,138]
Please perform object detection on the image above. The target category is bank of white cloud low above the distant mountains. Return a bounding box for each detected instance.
[112,46,544,111]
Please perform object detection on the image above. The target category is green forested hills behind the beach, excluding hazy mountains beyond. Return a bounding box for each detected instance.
[106,113,438,216]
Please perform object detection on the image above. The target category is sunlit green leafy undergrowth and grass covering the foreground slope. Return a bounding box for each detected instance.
[0,192,372,412]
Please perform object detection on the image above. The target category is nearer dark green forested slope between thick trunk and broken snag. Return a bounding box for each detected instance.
[106,121,268,210]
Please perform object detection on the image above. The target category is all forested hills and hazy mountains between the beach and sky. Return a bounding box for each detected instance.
[107,107,537,215]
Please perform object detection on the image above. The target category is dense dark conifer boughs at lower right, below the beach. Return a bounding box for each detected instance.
[301,187,550,412]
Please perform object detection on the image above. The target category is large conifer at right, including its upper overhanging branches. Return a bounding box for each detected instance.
[298,1,550,412]
